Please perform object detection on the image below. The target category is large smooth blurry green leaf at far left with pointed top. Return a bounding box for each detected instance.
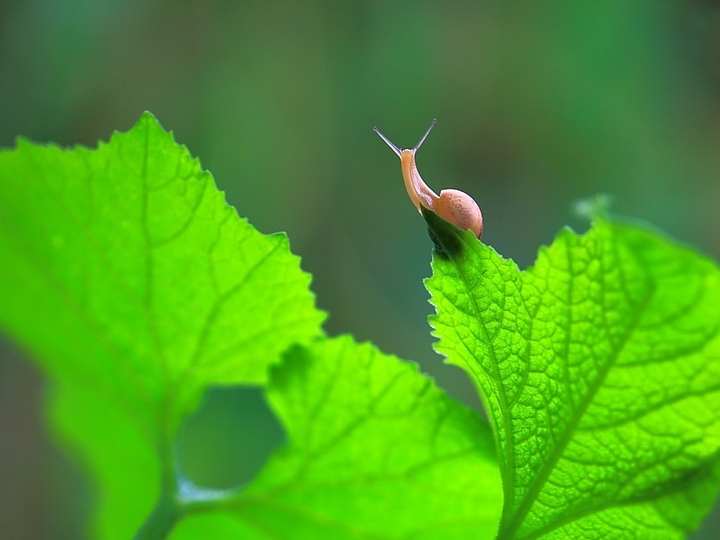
[0,113,323,539]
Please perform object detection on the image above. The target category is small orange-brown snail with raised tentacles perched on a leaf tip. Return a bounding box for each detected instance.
[373,118,483,238]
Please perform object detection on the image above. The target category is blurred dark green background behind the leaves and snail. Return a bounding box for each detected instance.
[0,0,720,539]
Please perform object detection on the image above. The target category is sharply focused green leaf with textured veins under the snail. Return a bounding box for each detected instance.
[426,213,720,539]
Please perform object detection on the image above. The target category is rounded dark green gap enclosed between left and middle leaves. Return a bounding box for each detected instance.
[178,386,285,489]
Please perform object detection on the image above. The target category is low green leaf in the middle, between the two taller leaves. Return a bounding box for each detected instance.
[171,337,502,540]
